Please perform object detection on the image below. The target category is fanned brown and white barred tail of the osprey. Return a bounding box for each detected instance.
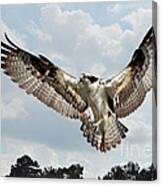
[81,116,128,152]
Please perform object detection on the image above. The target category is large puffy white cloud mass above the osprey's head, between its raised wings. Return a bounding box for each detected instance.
[30,5,128,77]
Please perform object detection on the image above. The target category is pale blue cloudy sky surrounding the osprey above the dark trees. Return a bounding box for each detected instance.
[0,0,155,178]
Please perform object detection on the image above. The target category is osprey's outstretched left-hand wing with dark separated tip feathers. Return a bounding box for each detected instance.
[1,34,86,119]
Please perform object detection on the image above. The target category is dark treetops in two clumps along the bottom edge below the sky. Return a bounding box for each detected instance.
[6,155,157,181]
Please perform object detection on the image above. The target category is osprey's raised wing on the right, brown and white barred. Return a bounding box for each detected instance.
[106,27,156,117]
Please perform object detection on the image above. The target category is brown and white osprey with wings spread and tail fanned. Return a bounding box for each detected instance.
[1,27,156,152]
